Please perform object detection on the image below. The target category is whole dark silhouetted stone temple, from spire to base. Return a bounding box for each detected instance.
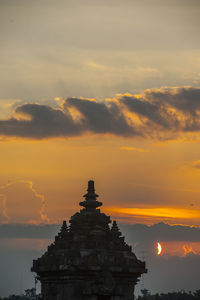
[32,180,146,300]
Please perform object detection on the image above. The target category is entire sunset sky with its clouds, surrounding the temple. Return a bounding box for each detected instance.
[0,0,200,296]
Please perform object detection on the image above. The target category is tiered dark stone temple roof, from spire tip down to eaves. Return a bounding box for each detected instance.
[32,180,146,278]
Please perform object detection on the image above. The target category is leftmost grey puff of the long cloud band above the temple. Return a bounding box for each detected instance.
[0,104,81,139]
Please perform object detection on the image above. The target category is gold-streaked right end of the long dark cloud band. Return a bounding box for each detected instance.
[120,87,200,132]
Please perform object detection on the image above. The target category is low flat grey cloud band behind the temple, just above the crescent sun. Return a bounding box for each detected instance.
[0,222,200,244]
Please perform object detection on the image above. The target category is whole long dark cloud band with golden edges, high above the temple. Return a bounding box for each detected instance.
[0,87,200,139]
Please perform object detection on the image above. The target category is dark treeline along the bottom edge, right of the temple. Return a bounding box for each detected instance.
[136,289,200,300]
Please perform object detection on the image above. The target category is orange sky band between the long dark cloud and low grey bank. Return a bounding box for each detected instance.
[0,135,200,225]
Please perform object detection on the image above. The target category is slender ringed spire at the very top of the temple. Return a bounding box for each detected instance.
[79,180,102,211]
